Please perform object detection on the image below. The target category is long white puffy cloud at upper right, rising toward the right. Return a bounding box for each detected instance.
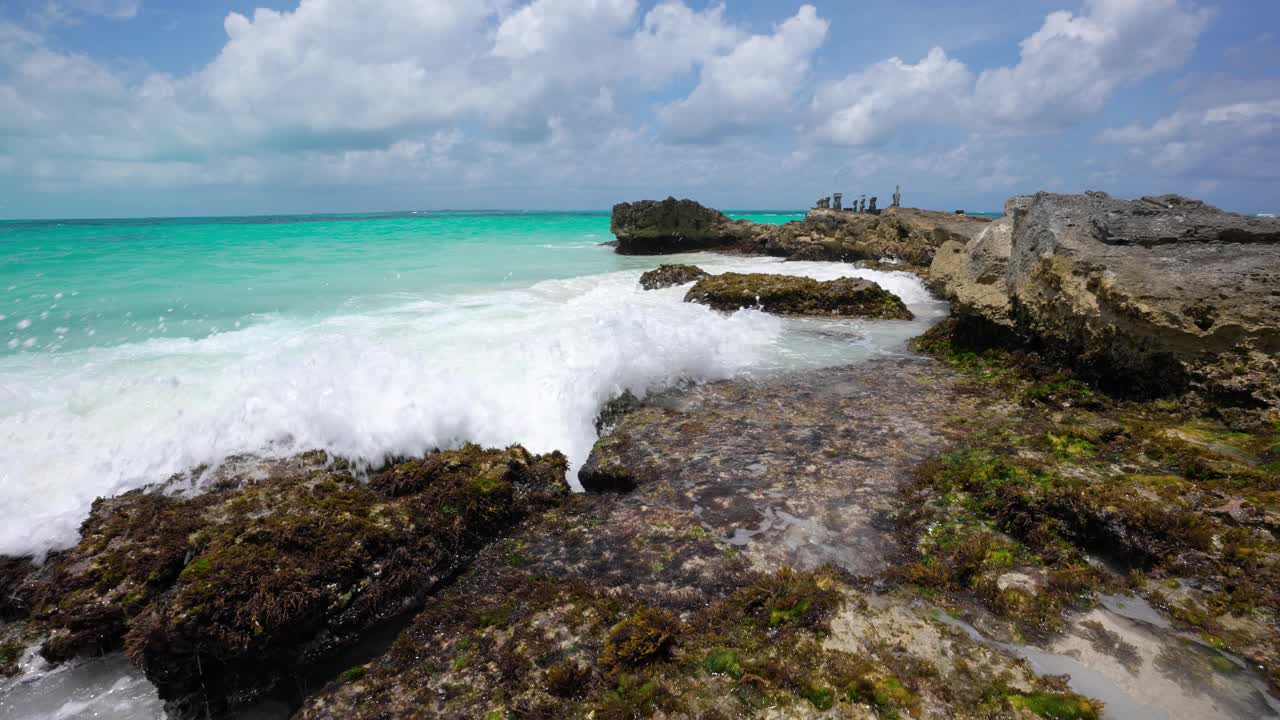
[813,0,1211,145]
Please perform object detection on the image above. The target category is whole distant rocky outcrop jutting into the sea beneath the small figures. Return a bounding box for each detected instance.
[609,197,991,268]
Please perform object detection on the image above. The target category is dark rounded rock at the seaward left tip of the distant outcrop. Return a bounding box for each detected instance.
[609,197,754,255]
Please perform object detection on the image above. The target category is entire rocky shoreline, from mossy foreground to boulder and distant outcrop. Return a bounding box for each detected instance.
[0,193,1280,719]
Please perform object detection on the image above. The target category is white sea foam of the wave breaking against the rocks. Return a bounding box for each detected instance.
[0,256,931,555]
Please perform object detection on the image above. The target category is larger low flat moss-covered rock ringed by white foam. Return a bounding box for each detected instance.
[685,273,914,320]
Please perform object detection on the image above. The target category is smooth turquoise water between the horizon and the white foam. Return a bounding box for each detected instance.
[0,213,803,354]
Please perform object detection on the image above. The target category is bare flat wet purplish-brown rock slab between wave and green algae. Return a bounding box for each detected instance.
[579,360,964,574]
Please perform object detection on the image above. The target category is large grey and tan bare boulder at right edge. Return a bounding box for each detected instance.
[929,192,1280,407]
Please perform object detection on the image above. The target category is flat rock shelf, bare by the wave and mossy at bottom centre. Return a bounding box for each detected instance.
[298,361,1097,719]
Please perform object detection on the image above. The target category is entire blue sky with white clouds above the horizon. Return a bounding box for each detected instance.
[0,0,1280,219]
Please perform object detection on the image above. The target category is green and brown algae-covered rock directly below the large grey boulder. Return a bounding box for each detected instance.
[897,316,1280,687]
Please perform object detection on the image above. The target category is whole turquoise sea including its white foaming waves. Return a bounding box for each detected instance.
[0,211,946,557]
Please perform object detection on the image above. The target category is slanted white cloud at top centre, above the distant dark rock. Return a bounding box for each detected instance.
[659,5,829,141]
